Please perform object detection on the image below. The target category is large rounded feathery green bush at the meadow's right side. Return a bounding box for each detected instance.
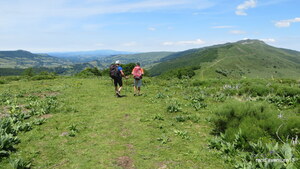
[213,101,286,141]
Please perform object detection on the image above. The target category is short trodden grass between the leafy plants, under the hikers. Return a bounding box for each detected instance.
[0,77,229,168]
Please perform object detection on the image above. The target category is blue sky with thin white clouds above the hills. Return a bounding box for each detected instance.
[0,0,300,52]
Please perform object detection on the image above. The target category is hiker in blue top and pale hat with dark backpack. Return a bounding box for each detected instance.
[110,60,128,97]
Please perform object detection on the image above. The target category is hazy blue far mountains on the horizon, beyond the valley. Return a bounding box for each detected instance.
[47,50,134,63]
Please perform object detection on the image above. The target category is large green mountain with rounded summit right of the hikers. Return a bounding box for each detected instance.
[150,40,300,78]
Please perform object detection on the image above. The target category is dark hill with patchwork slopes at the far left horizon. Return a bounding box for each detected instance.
[0,50,72,68]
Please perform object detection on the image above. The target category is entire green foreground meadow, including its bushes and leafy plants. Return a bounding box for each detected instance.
[0,76,300,169]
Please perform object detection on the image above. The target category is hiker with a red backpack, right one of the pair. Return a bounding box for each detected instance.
[131,62,144,96]
